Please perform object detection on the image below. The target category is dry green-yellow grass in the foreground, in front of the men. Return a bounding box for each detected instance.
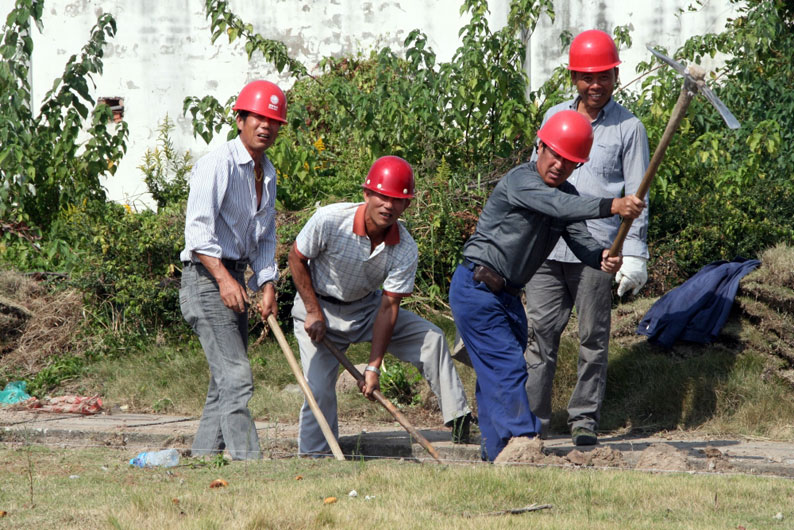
[0,446,794,529]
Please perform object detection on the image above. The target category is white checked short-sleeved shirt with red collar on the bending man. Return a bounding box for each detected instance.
[295,203,419,302]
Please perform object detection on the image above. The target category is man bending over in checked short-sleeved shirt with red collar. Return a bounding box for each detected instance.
[288,156,471,454]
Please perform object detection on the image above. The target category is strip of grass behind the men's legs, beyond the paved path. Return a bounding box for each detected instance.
[52,308,794,440]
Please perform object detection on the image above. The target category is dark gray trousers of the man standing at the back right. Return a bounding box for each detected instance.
[524,260,612,434]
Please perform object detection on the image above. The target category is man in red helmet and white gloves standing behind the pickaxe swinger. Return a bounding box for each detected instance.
[526,30,648,445]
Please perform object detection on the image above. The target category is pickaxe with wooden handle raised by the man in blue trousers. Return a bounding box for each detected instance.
[609,46,739,257]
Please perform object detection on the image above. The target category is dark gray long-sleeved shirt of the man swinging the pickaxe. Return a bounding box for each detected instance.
[463,162,612,287]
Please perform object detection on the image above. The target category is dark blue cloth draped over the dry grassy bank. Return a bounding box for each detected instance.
[637,257,761,348]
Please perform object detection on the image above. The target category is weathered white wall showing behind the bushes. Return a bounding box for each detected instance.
[29,0,732,208]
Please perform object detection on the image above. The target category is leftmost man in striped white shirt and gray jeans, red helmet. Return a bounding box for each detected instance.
[179,80,287,460]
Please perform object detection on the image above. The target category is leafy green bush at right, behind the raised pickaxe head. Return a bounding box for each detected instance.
[633,0,794,281]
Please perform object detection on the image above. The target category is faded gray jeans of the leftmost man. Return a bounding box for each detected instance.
[179,264,262,460]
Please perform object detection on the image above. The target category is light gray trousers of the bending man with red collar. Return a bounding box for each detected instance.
[292,291,470,454]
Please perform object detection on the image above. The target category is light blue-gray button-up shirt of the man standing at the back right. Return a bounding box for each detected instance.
[532,96,649,263]
